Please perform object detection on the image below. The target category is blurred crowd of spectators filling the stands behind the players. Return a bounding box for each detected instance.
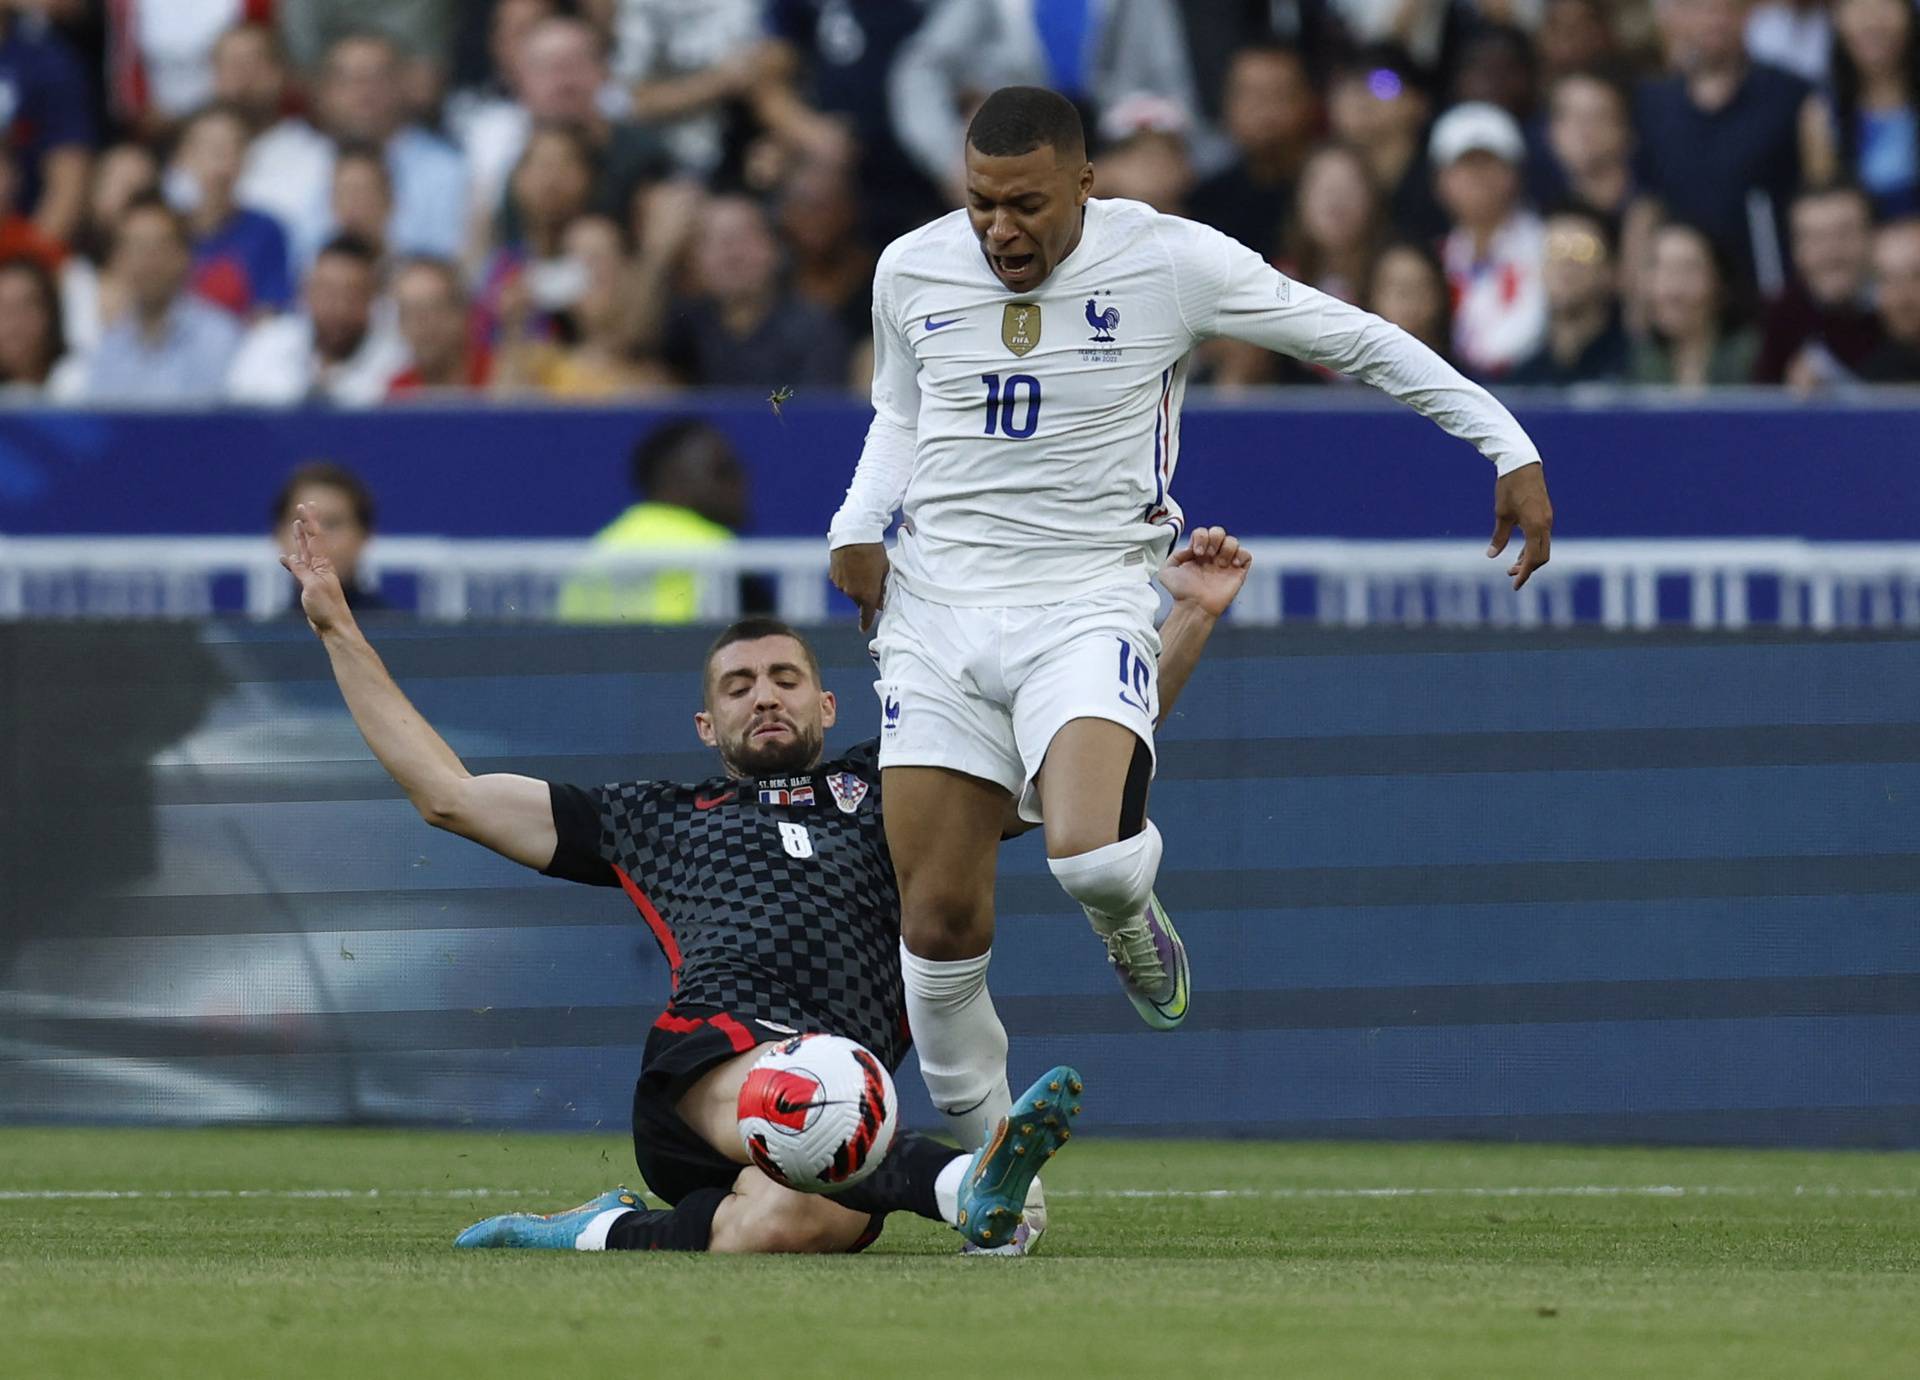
[0,0,1920,405]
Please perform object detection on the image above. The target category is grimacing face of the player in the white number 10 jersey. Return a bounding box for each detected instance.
[966,144,1092,292]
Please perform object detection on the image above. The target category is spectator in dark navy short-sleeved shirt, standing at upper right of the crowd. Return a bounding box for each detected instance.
[1634,0,1807,292]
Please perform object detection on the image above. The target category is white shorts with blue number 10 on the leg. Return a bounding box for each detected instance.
[874,580,1160,823]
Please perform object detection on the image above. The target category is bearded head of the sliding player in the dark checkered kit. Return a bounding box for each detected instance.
[693,637,835,775]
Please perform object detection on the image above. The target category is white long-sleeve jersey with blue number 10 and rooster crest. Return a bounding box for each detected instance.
[829,200,1540,605]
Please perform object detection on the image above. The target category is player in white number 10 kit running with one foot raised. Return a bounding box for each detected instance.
[829,86,1553,1174]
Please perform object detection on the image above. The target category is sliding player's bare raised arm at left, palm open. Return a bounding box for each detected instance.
[280,503,559,868]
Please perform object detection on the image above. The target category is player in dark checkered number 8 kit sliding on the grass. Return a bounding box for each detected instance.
[282,505,1250,1253]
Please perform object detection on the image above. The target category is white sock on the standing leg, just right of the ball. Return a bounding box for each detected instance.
[900,942,1014,1150]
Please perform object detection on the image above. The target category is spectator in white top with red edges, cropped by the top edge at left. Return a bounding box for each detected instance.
[108,0,273,136]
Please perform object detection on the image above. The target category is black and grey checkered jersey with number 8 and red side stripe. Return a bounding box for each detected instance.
[547,741,906,1069]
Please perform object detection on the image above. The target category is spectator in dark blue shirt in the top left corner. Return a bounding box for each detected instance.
[0,4,94,244]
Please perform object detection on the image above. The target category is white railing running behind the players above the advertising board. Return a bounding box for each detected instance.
[0,537,1920,630]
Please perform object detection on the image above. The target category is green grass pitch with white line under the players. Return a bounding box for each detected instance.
[0,1129,1920,1380]
